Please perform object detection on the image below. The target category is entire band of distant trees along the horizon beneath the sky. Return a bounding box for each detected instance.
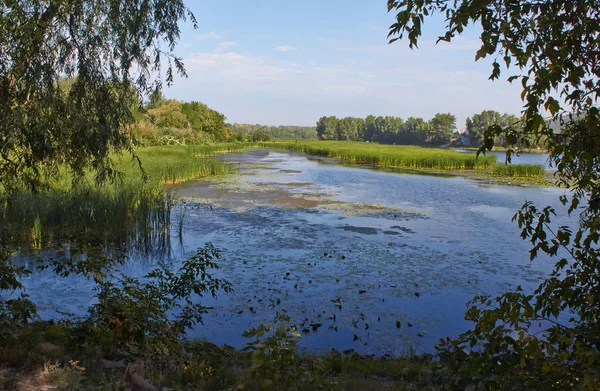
[132,93,521,146]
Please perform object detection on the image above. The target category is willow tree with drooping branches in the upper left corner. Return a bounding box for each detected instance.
[0,0,196,188]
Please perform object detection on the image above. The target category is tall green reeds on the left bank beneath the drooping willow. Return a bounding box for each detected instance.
[0,146,233,251]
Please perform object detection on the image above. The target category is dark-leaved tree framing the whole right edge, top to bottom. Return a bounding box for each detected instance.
[388,0,600,390]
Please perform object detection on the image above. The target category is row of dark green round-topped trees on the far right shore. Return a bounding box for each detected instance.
[316,110,520,146]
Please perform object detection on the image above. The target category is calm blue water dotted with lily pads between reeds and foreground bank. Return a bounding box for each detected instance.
[19,150,569,355]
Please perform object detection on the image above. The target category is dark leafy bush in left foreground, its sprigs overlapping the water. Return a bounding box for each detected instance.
[84,244,232,346]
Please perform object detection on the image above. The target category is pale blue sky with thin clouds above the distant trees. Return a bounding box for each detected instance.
[164,0,522,130]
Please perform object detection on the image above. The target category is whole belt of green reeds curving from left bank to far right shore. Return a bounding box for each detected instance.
[0,141,553,250]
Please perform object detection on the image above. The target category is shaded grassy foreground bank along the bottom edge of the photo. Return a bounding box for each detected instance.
[0,322,441,391]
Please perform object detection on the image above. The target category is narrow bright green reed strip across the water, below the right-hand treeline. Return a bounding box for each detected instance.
[261,141,496,170]
